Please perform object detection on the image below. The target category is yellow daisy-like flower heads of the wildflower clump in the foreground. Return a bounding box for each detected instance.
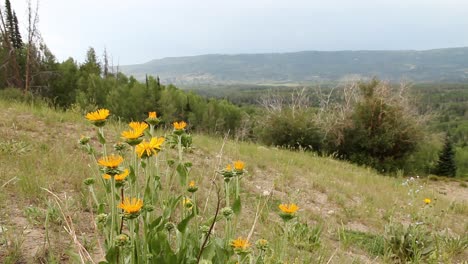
[86,109,302,262]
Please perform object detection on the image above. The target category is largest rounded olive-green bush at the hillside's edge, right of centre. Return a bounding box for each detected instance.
[329,79,424,172]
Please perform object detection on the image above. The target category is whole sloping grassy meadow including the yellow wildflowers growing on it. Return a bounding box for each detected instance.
[0,100,468,263]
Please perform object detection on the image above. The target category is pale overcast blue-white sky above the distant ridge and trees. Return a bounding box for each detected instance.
[9,0,468,65]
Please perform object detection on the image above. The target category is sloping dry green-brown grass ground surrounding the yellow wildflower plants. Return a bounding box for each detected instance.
[0,101,468,263]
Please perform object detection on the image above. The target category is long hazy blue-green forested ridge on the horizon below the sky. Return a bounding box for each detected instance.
[120,47,468,85]
